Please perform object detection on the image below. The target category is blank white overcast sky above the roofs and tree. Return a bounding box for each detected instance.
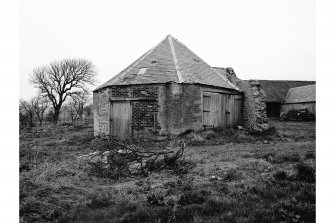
[20,0,315,99]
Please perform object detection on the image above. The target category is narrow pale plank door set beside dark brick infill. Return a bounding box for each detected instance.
[110,102,132,139]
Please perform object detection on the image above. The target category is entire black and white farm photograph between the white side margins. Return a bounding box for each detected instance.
[1,0,328,223]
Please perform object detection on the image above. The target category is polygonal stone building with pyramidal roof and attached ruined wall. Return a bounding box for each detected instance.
[93,35,267,138]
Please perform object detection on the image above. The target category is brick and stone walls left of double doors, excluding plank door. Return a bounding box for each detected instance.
[93,83,202,137]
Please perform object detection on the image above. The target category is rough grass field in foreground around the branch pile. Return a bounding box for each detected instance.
[20,121,315,222]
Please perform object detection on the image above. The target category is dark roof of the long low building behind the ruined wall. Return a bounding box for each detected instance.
[259,80,315,102]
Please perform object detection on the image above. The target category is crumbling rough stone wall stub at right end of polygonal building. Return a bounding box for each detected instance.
[226,67,269,131]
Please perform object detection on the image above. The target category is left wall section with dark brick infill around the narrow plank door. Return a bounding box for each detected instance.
[93,85,160,136]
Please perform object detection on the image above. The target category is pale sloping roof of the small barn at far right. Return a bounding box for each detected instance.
[285,84,316,103]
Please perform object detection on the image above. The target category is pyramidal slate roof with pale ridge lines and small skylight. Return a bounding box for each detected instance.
[95,35,239,90]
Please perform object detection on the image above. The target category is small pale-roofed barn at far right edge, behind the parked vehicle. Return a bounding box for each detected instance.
[281,84,316,115]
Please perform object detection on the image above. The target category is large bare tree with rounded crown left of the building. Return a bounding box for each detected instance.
[30,59,96,123]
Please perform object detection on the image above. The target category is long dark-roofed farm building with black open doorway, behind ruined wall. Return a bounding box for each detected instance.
[259,80,315,118]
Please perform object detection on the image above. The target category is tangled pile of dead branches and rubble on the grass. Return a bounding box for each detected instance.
[78,138,186,178]
